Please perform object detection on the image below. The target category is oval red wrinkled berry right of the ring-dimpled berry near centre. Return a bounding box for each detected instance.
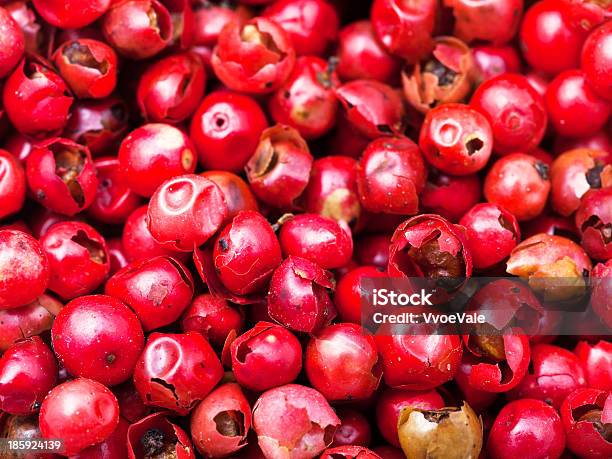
[213,211,282,295]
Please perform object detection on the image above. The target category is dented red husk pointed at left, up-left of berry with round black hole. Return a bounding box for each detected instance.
[335,80,404,140]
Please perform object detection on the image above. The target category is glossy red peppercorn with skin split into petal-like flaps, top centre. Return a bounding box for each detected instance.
[211,16,295,94]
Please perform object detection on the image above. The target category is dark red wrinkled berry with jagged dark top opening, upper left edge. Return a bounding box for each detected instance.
[3,56,74,138]
